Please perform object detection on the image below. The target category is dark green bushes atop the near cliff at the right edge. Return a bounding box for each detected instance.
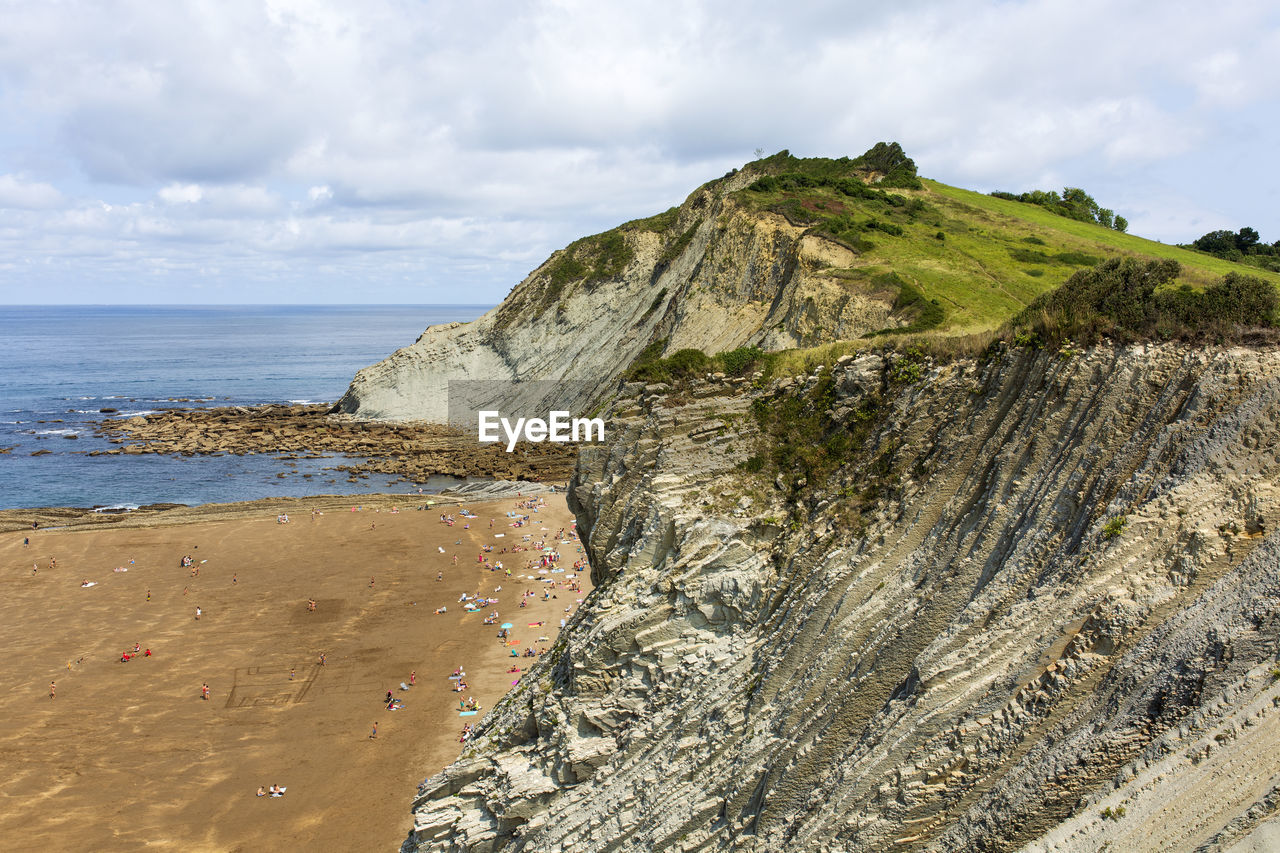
[1009,257,1276,343]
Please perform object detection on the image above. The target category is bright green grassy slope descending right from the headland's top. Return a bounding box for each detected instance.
[735,154,1280,336]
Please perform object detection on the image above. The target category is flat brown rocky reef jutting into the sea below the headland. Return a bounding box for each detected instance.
[90,405,576,483]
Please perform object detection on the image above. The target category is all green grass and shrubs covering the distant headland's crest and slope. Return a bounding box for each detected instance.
[499,143,1280,338]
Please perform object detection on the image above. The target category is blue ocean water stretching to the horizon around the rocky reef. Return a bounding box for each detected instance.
[0,305,489,508]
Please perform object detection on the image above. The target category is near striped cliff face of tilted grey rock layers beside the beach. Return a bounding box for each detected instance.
[404,346,1280,852]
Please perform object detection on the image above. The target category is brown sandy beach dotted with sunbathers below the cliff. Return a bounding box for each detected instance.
[0,496,589,850]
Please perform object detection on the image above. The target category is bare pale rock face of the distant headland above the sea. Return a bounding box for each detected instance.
[334,170,899,423]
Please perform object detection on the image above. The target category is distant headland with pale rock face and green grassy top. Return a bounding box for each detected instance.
[333,143,1280,425]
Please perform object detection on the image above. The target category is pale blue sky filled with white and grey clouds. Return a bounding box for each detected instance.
[0,0,1280,304]
